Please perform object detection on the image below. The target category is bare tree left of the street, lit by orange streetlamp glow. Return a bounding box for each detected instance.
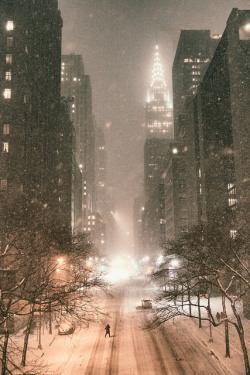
[0,198,107,375]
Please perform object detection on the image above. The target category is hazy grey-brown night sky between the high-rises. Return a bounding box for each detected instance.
[59,0,250,253]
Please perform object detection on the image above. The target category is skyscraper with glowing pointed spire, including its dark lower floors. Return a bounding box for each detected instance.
[141,46,174,255]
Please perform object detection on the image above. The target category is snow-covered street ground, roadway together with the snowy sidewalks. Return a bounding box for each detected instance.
[12,279,250,375]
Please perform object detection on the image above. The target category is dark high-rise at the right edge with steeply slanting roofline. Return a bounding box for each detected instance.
[187,9,250,226]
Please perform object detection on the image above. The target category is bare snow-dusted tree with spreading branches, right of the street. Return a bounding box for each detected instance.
[147,214,250,375]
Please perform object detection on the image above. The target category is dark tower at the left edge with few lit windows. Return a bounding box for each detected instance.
[0,0,70,234]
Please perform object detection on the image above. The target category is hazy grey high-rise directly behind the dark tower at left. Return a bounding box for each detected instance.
[61,54,96,232]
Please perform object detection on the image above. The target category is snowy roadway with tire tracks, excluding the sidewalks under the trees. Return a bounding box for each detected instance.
[45,280,234,375]
